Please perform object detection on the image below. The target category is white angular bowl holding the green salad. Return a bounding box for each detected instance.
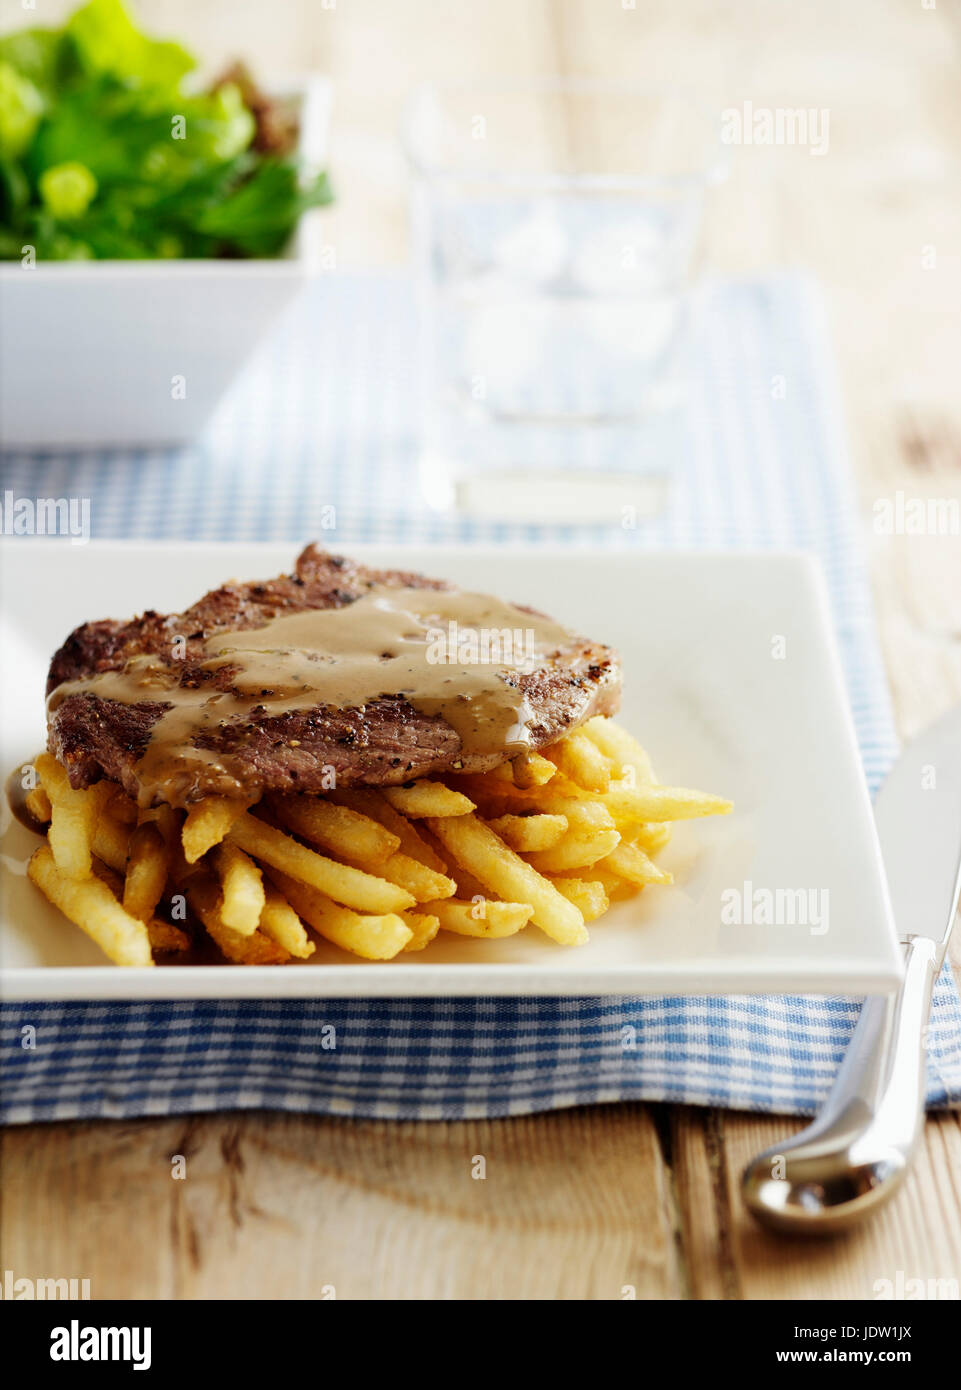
[0,79,330,450]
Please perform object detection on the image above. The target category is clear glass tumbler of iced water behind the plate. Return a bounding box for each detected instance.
[405,79,723,523]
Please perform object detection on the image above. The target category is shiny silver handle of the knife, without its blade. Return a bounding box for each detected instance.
[741,937,937,1234]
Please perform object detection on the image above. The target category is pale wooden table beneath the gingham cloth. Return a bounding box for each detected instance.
[1,0,961,1298]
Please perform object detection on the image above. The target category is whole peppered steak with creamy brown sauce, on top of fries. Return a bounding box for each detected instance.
[47,545,620,806]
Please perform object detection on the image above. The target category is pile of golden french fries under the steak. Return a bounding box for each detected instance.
[20,717,732,966]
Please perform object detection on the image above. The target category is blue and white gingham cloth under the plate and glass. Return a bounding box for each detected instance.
[0,275,961,1123]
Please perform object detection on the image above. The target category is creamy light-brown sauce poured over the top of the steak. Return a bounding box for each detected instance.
[47,587,570,803]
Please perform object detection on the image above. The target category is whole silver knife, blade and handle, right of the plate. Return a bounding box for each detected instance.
[741,709,961,1234]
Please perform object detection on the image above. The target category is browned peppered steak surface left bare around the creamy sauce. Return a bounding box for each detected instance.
[47,545,620,805]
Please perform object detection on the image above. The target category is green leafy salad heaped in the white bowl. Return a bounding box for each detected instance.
[0,0,331,261]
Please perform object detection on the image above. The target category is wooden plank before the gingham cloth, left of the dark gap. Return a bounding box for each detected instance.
[1,1105,684,1300]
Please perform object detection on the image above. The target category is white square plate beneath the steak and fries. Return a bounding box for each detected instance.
[0,541,900,999]
